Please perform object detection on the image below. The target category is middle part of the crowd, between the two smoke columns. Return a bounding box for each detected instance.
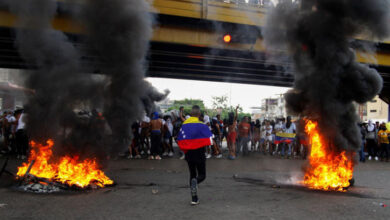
[128,107,307,160]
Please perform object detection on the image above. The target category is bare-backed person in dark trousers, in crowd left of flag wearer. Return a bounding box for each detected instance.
[149,112,163,160]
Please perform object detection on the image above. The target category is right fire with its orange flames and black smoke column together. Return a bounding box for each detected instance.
[262,0,390,191]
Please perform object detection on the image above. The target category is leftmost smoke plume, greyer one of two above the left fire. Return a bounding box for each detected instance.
[8,0,101,144]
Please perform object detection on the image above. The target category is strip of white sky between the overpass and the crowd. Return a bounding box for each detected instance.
[146,78,289,113]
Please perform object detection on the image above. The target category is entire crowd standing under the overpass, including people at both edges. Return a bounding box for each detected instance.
[0,107,390,162]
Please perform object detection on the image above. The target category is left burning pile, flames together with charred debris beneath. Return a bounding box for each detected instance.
[17,140,114,192]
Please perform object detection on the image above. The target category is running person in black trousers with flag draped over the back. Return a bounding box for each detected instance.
[177,105,212,205]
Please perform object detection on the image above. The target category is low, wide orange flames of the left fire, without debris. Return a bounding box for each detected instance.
[17,140,114,188]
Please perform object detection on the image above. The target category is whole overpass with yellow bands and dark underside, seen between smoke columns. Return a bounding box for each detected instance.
[0,0,390,102]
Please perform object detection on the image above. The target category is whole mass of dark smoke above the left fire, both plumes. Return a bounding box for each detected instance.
[6,0,168,158]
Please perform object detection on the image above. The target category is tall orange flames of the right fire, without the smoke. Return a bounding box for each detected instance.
[303,120,353,192]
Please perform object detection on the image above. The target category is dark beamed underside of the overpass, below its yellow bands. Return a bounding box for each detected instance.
[0,24,390,101]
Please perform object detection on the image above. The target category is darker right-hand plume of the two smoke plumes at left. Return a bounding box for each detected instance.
[82,0,168,153]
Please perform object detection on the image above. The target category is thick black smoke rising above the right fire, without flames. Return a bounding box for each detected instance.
[263,0,390,150]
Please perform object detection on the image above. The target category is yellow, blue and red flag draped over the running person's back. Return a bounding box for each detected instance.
[177,117,213,152]
